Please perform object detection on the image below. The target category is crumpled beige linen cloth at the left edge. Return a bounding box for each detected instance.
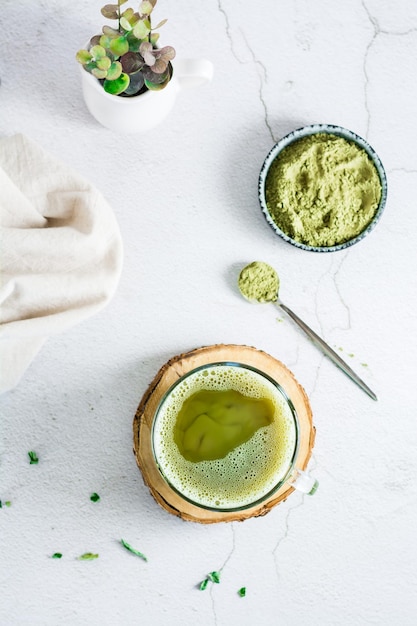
[0,135,122,393]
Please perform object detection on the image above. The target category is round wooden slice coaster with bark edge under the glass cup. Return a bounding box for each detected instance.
[133,344,316,524]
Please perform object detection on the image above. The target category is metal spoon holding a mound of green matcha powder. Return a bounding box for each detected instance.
[238,261,378,400]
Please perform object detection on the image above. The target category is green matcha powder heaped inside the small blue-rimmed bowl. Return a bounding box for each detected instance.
[265,133,382,247]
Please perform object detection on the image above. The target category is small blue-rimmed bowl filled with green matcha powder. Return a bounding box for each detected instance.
[259,124,387,252]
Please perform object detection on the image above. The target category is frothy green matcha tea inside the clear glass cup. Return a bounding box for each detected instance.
[153,364,297,510]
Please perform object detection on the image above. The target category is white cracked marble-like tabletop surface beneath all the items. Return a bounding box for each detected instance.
[0,0,417,626]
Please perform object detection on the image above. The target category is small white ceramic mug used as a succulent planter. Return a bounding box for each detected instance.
[80,59,213,134]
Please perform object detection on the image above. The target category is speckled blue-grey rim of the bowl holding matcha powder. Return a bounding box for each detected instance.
[258,124,388,252]
